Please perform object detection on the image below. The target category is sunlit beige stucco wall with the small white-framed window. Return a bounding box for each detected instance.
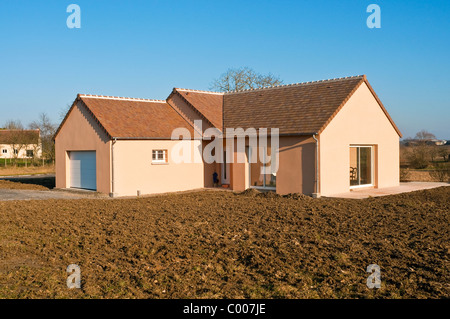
[113,140,204,196]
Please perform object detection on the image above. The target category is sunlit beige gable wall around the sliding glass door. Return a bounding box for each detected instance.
[319,83,399,196]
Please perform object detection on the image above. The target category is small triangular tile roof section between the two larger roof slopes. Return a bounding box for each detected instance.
[173,88,224,130]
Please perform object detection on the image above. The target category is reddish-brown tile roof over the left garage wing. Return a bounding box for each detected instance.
[55,94,194,139]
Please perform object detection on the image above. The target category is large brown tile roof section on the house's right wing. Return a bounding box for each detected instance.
[223,75,401,136]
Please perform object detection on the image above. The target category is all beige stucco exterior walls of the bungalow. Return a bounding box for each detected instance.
[55,84,399,196]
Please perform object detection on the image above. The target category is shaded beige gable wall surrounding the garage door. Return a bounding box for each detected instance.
[55,102,111,194]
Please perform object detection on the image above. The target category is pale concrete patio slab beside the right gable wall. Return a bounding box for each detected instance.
[324,182,450,199]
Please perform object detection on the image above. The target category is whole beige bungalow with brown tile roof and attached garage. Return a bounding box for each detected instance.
[55,75,401,196]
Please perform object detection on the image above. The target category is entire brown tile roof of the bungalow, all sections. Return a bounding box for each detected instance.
[55,75,402,138]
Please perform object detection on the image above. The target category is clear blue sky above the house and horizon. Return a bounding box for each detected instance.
[0,0,450,139]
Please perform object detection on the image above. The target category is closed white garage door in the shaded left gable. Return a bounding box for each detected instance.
[69,151,97,190]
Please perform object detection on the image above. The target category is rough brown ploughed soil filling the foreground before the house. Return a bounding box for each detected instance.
[0,187,450,298]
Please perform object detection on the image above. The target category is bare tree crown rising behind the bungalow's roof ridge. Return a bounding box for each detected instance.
[211,67,283,92]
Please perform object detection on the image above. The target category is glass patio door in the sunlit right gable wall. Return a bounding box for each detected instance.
[350,146,373,187]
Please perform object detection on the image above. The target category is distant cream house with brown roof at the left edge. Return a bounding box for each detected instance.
[0,129,42,159]
